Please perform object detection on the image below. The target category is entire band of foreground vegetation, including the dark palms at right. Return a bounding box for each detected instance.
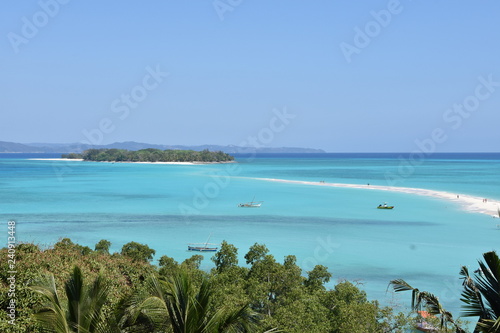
[0,238,500,333]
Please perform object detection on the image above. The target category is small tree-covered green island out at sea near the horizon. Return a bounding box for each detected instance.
[61,148,234,163]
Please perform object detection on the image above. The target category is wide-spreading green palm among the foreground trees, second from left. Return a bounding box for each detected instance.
[122,271,258,333]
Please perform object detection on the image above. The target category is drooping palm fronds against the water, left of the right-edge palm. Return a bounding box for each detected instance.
[389,279,465,333]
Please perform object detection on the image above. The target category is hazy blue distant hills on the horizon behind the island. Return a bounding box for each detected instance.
[0,141,325,154]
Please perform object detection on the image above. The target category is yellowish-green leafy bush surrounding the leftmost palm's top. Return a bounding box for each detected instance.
[0,239,155,333]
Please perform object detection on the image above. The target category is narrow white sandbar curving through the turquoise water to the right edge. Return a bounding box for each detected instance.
[250,177,500,218]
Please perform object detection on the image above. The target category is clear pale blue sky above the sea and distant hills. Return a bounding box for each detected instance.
[0,0,500,152]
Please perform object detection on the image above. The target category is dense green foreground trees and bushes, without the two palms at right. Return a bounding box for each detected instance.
[0,239,418,333]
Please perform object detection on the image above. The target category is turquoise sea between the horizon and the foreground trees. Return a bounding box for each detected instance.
[0,154,500,315]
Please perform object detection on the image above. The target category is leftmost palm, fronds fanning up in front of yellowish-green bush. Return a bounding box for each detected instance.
[30,266,115,333]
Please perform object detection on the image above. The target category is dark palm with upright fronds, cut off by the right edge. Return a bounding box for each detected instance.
[460,251,500,332]
